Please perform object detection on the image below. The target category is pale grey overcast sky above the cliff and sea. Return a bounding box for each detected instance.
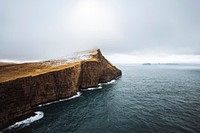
[0,0,200,63]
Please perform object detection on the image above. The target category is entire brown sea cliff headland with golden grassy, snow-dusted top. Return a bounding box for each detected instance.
[0,49,121,129]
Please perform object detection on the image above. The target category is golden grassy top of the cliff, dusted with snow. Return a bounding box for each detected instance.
[0,49,99,83]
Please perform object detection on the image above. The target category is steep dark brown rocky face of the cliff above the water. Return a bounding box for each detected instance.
[0,50,121,129]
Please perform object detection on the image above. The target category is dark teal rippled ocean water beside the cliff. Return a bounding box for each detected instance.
[3,65,200,133]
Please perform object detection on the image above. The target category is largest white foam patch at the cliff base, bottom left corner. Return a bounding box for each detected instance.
[3,111,44,131]
